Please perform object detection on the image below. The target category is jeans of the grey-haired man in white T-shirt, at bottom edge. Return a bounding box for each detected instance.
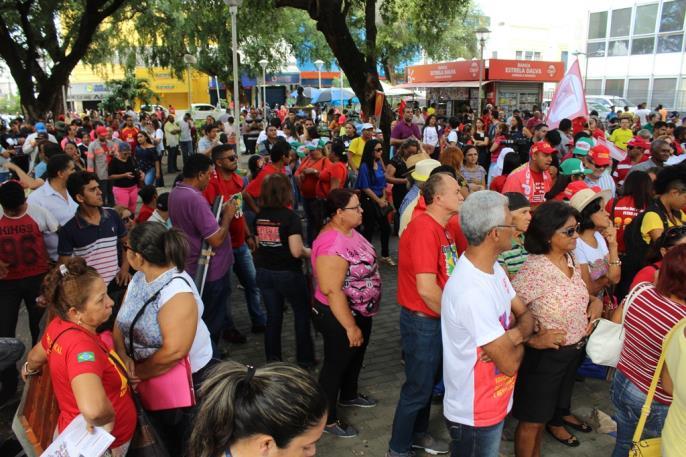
[445,419,505,457]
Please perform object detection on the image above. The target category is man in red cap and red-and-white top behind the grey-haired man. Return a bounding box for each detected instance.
[503,141,556,207]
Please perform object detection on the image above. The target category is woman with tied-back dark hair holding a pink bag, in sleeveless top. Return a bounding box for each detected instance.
[114,222,212,450]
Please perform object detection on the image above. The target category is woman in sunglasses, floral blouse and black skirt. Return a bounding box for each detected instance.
[512,201,602,457]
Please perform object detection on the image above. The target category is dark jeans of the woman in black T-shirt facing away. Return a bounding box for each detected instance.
[257,268,314,366]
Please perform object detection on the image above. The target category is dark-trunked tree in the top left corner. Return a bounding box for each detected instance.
[0,0,136,119]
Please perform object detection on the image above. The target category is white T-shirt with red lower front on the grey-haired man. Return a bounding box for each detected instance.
[441,255,516,427]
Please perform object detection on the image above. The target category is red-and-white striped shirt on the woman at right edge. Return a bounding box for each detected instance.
[617,284,686,405]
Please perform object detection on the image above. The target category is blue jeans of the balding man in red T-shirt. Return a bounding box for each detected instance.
[388,308,443,454]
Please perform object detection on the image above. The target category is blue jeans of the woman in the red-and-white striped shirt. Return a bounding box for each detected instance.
[610,371,669,457]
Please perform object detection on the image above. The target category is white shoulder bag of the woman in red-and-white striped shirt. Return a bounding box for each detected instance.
[586,282,650,367]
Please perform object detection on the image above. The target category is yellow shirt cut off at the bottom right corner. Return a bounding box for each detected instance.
[662,320,686,457]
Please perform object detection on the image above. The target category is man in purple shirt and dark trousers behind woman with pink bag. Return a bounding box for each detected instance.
[169,154,236,350]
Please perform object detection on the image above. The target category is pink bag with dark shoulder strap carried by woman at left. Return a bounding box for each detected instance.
[127,276,195,411]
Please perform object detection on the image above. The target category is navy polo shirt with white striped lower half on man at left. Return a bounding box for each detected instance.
[57,208,126,284]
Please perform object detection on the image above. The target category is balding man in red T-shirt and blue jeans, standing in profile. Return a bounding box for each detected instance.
[388,173,462,456]
